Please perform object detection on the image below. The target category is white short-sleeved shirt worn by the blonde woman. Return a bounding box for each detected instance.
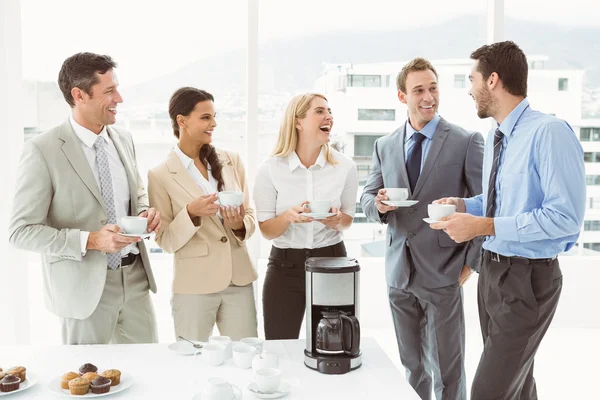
[254,148,358,249]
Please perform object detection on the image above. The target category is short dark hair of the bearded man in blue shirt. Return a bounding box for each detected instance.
[471,40,529,97]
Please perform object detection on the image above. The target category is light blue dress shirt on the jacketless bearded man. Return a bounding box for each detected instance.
[465,98,586,258]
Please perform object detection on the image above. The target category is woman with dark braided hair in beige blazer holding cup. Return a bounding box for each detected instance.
[148,87,257,341]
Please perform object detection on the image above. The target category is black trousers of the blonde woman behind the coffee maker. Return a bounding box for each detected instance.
[262,242,346,340]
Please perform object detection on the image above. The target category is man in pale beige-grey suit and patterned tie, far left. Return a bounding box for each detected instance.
[10,53,160,344]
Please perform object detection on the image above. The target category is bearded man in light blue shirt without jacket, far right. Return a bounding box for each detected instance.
[431,41,586,400]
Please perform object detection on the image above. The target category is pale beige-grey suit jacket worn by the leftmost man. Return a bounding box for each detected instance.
[9,120,156,319]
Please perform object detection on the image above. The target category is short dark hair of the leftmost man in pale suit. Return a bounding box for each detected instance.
[58,53,117,107]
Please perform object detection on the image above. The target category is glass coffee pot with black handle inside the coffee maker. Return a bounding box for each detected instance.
[316,311,360,356]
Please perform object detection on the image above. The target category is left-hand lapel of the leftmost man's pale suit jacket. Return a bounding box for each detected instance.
[58,120,106,210]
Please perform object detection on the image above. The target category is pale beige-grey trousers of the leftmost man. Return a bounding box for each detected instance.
[61,256,158,344]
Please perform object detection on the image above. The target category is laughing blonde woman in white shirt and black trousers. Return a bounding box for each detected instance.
[254,93,358,339]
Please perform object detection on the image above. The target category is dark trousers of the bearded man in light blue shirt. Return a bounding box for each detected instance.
[471,251,562,400]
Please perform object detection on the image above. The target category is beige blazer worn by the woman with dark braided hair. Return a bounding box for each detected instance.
[148,150,258,294]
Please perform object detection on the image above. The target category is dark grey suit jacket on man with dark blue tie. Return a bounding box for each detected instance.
[360,118,483,289]
